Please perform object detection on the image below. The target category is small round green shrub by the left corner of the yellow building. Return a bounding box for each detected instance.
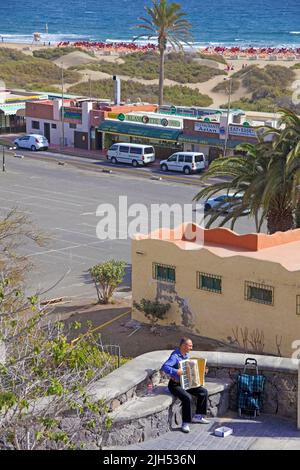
[89,259,126,304]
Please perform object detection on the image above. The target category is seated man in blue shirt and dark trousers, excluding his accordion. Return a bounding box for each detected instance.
[161,338,209,432]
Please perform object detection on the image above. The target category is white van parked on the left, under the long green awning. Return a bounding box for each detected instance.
[107,143,155,166]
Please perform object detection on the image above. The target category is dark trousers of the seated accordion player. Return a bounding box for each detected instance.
[168,380,208,423]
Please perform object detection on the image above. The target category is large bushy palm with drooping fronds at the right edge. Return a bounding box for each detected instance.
[195,109,300,233]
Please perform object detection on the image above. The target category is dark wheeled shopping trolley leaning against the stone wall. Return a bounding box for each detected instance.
[237,357,265,417]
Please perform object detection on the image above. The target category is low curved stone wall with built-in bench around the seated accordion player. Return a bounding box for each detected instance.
[5,351,298,449]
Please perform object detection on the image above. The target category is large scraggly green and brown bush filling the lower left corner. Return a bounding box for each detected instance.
[0,210,114,450]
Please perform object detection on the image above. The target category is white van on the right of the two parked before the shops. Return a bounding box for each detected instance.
[160,152,207,175]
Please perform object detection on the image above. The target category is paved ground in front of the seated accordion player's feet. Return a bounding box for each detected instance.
[111,413,300,450]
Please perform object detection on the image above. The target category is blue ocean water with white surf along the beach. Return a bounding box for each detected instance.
[0,0,300,47]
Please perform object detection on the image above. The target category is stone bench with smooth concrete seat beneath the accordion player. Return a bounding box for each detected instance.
[102,378,230,448]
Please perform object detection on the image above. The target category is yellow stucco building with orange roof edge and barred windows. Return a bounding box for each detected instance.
[132,224,300,357]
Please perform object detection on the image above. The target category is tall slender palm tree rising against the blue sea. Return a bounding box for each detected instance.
[135,0,193,105]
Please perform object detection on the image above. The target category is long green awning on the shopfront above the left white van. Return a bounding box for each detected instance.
[98,120,181,142]
